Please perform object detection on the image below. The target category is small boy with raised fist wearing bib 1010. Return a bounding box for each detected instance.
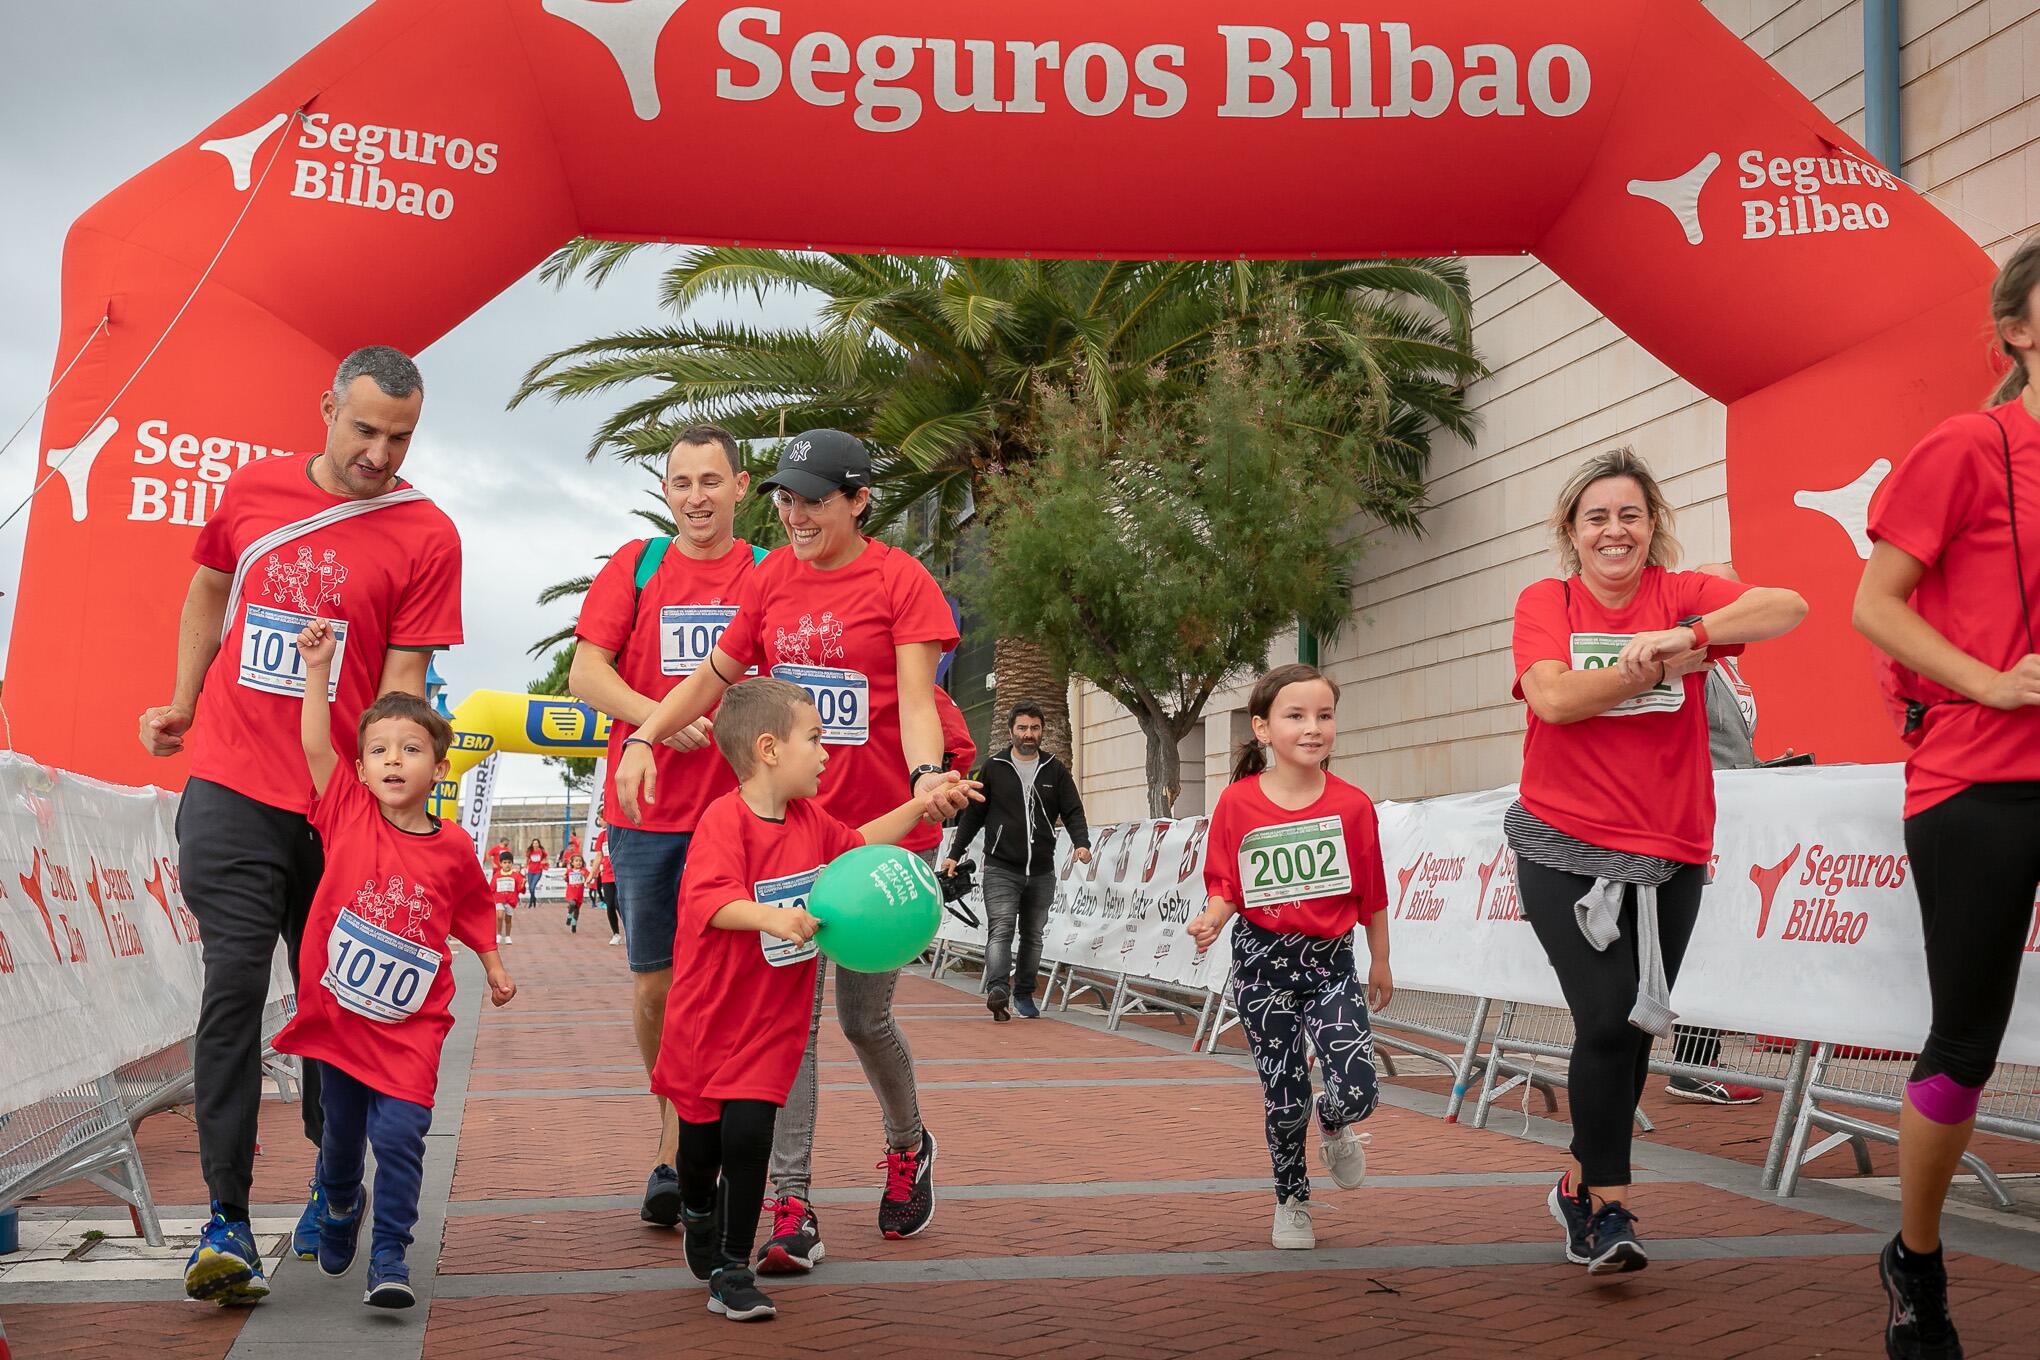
[275,620,516,1309]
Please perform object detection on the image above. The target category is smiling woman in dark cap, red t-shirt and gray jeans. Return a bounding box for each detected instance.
[616,430,973,1272]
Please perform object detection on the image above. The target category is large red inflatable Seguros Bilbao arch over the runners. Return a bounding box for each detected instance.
[6,0,1991,781]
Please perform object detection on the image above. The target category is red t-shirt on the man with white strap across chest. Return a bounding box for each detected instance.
[186,459,461,812]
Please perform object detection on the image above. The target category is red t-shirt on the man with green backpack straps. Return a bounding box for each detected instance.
[573,538,755,832]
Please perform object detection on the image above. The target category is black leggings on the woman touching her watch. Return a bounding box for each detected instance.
[1516,856,1705,1189]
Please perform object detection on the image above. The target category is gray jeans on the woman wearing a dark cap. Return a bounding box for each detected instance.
[771,850,934,1199]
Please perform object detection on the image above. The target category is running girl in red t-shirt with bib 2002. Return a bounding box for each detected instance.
[1185,665,1393,1250]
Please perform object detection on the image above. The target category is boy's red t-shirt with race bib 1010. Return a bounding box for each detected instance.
[275,763,496,1105]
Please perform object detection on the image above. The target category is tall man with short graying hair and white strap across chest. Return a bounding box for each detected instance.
[141,345,461,1305]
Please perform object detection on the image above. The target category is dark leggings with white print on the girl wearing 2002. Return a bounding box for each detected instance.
[1232,916,1379,1201]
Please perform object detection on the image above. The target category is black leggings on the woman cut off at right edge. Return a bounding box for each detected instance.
[1905,781,2040,1087]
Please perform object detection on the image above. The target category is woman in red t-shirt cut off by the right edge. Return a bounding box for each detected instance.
[1854,239,2040,1356]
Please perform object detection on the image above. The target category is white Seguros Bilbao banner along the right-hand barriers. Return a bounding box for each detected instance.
[958,765,2040,1062]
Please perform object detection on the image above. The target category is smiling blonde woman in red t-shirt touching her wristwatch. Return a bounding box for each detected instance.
[1503,449,1805,1274]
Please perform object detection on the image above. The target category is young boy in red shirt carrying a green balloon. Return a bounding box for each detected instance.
[652,679,975,1321]
